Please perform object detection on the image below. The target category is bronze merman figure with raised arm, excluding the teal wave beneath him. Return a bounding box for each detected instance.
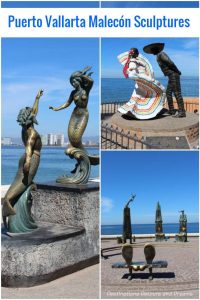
[2,90,43,232]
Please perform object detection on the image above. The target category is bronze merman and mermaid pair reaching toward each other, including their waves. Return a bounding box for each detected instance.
[2,67,99,232]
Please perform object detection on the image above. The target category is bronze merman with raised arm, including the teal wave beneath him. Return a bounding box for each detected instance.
[2,90,43,232]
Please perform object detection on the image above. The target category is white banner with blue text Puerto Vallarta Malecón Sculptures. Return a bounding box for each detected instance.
[0,8,200,37]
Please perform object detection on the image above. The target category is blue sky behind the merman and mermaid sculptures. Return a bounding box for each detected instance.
[2,38,99,137]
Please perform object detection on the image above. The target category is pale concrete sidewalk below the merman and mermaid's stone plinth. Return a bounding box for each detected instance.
[1,264,99,299]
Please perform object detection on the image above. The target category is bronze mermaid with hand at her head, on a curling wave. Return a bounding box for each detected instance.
[49,67,99,184]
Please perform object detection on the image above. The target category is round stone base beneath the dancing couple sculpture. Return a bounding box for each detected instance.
[106,112,199,149]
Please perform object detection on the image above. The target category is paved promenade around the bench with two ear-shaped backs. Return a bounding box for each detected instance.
[101,238,199,299]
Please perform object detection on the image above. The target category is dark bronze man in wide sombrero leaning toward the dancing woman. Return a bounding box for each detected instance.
[143,43,186,118]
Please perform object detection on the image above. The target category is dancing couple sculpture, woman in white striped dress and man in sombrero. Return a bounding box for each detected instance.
[118,43,186,120]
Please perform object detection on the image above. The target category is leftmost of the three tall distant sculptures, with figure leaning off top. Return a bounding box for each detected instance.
[123,195,136,244]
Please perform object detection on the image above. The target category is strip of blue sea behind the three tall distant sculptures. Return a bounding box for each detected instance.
[101,223,199,235]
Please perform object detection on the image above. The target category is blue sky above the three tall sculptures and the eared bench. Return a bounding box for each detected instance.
[101,151,199,225]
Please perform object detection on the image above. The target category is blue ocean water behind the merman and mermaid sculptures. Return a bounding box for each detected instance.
[1,146,99,185]
